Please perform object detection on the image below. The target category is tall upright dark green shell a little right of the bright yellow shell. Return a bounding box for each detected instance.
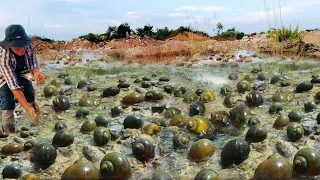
[229,103,248,128]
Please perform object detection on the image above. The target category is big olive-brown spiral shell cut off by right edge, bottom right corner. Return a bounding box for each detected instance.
[293,148,320,176]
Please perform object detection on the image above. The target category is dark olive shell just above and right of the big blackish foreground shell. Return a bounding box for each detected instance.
[246,125,268,143]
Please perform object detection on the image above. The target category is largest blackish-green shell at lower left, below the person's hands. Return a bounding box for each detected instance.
[29,144,57,165]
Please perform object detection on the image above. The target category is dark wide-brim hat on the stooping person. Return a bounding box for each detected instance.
[0,24,31,49]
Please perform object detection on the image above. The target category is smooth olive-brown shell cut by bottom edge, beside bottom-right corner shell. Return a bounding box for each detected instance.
[254,157,292,180]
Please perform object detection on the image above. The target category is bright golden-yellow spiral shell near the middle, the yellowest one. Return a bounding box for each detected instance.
[187,115,210,134]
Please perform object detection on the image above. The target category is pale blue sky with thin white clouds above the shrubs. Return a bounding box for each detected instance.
[0,0,320,40]
